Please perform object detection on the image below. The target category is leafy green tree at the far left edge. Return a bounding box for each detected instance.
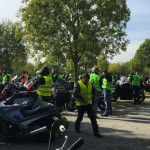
[0,21,27,71]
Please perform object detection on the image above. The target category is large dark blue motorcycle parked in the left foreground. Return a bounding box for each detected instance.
[0,92,68,142]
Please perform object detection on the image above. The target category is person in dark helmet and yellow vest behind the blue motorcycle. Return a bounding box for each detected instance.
[33,67,53,102]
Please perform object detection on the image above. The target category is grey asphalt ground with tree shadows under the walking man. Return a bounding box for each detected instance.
[0,96,150,150]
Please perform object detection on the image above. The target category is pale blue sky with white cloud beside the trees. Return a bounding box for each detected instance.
[0,0,150,63]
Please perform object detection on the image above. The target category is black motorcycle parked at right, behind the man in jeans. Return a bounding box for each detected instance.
[111,83,145,104]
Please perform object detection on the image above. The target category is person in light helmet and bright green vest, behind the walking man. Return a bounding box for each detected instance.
[90,67,101,118]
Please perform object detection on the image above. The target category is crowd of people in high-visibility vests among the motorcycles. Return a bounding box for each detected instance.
[0,67,149,138]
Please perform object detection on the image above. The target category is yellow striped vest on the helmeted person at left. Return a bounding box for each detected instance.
[37,76,52,96]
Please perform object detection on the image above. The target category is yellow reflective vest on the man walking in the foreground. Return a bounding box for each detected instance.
[76,80,92,106]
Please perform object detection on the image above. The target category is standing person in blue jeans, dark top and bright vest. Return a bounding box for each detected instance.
[101,70,113,116]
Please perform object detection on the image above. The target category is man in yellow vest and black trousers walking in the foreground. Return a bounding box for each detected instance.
[74,73,102,138]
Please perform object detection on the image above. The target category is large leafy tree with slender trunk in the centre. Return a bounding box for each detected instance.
[20,0,130,81]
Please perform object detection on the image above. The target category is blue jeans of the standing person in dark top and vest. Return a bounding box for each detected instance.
[103,89,112,114]
